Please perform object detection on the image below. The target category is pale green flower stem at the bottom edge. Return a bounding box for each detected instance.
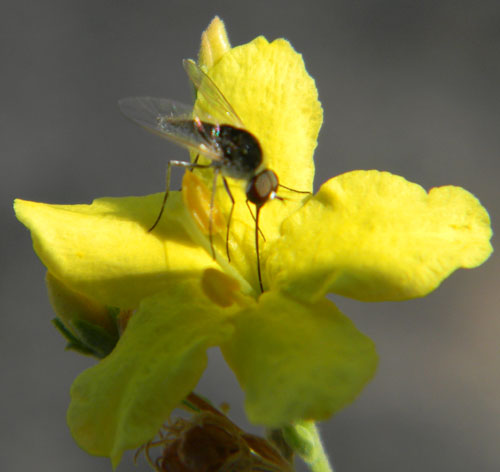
[283,421,334,472]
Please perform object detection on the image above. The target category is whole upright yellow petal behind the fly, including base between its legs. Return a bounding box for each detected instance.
[189,37,323,287]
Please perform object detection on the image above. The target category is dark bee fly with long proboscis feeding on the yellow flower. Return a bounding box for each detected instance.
[118,59,282,292]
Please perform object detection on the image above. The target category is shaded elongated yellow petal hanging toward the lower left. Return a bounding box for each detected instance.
[68,283,231,466]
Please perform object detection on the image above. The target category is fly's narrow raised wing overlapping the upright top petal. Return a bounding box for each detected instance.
[182,59,244,128]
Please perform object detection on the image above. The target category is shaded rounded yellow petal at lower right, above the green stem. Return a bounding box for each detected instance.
[222,292,377,427]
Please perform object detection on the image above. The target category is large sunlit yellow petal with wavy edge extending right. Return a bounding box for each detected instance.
[265,171,492,301]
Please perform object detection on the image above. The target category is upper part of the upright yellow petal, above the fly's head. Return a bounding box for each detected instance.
[209,37,323,190]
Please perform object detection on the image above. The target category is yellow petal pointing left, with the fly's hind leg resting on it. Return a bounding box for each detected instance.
[15,192,217,308]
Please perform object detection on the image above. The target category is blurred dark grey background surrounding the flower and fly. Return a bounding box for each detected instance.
[0,0,500,472]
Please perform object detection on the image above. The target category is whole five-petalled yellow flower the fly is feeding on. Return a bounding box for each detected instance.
[12,15,492,465]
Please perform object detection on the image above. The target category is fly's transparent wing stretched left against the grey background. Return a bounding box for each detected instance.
[118,97,221,160]
